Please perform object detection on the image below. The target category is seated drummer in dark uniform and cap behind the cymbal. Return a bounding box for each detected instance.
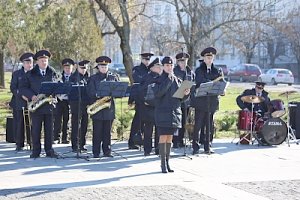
[236,81,270,117]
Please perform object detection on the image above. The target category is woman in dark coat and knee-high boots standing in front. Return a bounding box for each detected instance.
[153,56,190,173]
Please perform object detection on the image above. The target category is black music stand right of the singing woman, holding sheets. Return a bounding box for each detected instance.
[195,81,228,154]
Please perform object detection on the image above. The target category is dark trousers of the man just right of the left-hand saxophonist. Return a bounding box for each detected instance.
[54,100,69,141]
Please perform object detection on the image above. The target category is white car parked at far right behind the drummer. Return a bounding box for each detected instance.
[258,69,294,85]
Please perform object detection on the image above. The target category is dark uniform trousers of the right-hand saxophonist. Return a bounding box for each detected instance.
[93,119,113,156]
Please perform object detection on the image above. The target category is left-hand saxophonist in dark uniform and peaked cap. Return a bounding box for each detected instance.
[22,50,58,158]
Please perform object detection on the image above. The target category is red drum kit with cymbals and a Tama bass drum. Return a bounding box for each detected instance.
[236,91,298,146]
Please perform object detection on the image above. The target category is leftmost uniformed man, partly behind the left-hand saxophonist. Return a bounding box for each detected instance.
[10,52,34,151]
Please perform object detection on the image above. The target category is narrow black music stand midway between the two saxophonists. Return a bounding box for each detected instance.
[63,83,89,161]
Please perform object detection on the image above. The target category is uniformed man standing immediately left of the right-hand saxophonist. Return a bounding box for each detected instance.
[69,60,90,152]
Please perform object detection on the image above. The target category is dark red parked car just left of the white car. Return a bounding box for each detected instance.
[228,64,261,82]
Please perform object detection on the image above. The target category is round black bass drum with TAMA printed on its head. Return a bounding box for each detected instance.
[258,118,288,145]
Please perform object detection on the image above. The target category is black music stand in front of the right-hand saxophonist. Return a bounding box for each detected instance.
[96,81,128,160]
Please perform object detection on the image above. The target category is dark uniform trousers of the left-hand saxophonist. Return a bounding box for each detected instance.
[31,113,53,155]
